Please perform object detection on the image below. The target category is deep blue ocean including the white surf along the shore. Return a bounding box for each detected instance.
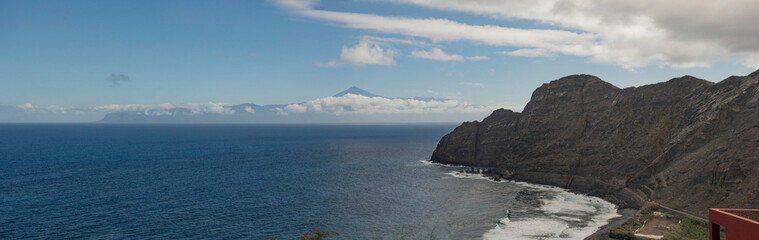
[0,124,618,239]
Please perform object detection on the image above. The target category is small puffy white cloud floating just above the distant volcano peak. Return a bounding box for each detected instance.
[318,39,398,67]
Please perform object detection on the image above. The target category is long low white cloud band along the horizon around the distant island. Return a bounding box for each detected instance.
[0,88,510,122]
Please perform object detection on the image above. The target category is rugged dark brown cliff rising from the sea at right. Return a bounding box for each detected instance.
[432,71,759,215]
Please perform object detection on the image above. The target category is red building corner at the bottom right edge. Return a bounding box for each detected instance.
[709,208,759,240]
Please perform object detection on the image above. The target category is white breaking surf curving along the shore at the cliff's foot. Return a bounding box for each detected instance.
[422,160,621,240]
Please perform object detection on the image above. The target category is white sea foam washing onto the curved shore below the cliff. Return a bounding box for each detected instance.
[436,167,620,240]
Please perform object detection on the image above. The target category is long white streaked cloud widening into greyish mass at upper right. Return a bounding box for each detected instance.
[283,0,759,70]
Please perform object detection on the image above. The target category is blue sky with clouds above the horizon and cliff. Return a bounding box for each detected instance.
[0,0,759,122]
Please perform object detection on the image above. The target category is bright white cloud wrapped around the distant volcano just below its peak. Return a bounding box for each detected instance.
[285,94,497,115]
